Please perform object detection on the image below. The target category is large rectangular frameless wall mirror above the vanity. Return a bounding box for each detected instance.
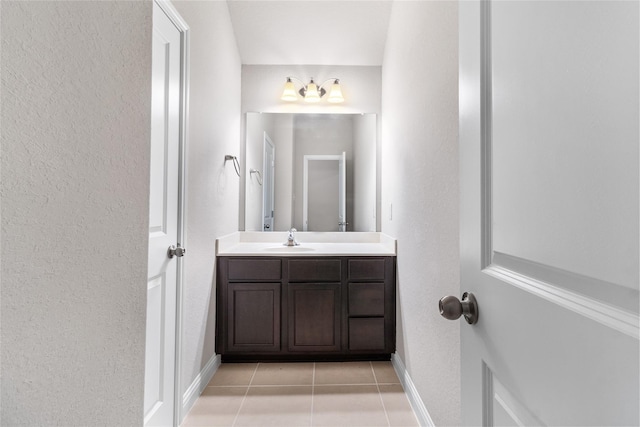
[244,113,379,231]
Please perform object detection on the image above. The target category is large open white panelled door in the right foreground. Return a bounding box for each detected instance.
[459,1,640,426]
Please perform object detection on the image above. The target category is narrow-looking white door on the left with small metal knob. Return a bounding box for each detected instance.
[144,2,182,426]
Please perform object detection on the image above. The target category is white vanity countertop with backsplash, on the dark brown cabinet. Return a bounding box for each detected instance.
[216,231,396,256]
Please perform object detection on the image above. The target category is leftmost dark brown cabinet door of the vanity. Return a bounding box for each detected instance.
[227,283,280,353]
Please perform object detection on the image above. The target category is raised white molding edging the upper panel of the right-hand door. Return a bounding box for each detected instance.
[480,0,640,339]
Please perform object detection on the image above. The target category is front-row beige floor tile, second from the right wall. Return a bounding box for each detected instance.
[312,385,388,427]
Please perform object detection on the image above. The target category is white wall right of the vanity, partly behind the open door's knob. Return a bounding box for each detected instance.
[382,1,460,425]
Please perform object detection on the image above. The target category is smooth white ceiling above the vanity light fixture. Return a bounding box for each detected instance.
[227,0,392,66]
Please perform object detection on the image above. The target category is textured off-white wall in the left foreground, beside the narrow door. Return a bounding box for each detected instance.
[0,1,152,426]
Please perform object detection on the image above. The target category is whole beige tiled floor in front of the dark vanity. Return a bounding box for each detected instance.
[182,362,418,427]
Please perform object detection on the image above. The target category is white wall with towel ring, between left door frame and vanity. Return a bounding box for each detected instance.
[173,1,241,408]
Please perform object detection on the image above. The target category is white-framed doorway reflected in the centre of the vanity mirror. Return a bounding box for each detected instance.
[302,152,348,231]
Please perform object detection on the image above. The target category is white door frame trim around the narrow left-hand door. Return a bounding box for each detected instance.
[154,0,190,426]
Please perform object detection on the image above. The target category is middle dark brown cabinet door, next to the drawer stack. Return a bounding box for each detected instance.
[288,283,341,351]
